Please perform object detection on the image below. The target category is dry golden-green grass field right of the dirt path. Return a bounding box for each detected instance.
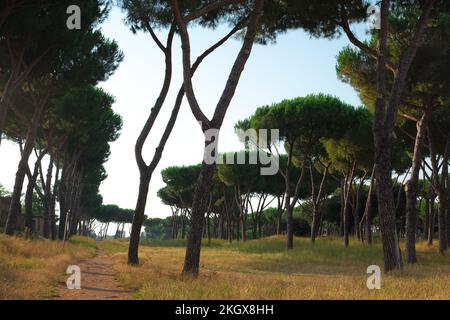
[102,238,450,299]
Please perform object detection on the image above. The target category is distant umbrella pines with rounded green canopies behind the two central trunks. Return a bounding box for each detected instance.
[158,95,400,248]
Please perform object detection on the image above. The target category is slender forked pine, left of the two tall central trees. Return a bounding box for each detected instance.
[121,0,253,264]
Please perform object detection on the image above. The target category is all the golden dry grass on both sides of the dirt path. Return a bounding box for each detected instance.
[0,236,450,300]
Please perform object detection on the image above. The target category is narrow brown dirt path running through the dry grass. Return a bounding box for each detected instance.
[57,244,131,300]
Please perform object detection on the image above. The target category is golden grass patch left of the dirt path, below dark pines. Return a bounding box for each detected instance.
[0,235,95,299]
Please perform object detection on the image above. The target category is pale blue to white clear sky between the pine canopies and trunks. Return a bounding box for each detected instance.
[0,8,365,222]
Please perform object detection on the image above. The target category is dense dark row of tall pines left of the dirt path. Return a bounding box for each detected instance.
[0,0,123,239]
